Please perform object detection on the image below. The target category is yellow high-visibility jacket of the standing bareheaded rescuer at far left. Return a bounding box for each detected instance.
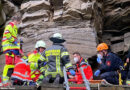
[2,22,20,52]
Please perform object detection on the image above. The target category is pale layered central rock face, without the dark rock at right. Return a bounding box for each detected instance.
[20,0,102,58]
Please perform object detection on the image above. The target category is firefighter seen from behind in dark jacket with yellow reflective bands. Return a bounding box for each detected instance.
[38,33,75,84]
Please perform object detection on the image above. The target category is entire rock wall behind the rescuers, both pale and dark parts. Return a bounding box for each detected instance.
[0,0,130,73]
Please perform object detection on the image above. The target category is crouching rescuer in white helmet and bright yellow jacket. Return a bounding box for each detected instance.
[28,40,46,84]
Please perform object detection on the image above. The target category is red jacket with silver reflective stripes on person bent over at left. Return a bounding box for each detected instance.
[11,58,32,81]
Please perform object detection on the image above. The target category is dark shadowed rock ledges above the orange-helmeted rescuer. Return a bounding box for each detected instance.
[103,0,130,54]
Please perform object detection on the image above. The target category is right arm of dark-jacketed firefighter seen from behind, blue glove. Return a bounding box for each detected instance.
[61,47,75,76]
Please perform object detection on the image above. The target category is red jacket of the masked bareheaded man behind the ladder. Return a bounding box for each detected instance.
[75,57,93,84]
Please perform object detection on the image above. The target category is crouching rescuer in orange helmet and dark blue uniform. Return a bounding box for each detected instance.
[94,43,123,84]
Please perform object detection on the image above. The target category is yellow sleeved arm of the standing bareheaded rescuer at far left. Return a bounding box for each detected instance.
[4,25,16,43]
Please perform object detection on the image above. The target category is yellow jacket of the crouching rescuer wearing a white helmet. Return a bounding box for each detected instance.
[28,50,44,81]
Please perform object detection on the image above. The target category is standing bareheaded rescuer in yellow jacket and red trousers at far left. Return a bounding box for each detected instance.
[2,16,21,84]
